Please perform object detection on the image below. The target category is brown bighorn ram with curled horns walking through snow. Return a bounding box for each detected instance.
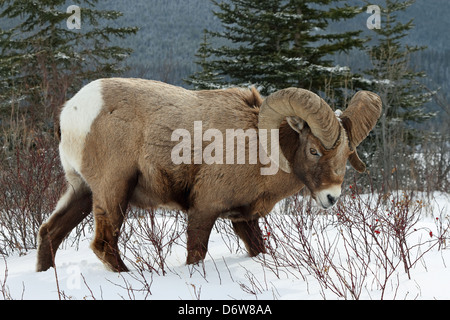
[37,78,381,271]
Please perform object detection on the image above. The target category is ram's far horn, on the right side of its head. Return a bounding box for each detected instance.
[340,91,383,172]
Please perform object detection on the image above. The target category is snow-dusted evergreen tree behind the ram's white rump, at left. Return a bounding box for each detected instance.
[0,0,137,126]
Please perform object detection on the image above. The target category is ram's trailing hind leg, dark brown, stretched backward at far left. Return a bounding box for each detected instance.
[36,173,92,272]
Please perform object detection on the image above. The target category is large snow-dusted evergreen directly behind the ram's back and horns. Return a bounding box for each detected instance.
[188,0,364,94]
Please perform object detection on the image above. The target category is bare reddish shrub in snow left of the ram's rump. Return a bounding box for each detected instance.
[0,134,64,254]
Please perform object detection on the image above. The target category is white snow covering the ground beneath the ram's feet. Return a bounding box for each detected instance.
[0,193,450,300]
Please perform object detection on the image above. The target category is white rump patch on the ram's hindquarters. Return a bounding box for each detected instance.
[59,80,103,173]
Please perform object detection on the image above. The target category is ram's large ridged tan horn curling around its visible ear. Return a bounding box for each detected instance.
[258,88,340,173]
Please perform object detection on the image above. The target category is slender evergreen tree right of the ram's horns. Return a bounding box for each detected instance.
[356,0,434,188]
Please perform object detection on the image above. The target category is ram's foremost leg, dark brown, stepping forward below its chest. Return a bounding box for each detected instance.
[232,219,266,257]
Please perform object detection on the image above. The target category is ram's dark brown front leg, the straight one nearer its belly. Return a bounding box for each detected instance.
[186,211,217,264]
